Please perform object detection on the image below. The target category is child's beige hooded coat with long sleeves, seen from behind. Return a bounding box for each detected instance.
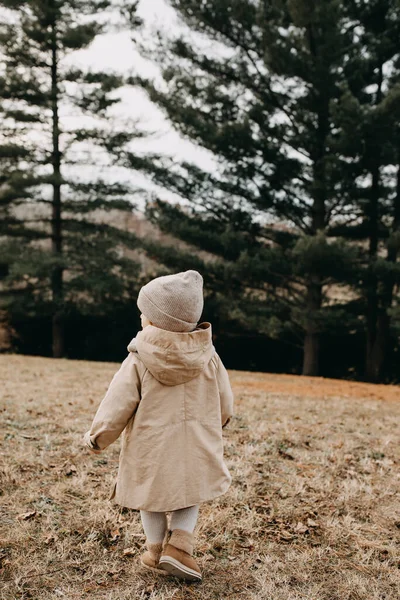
[85,323,233,512]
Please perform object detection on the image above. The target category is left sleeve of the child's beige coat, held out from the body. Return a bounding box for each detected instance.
[84,353,141,452]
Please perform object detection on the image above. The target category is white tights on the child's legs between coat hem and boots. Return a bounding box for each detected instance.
[140,504,199,544]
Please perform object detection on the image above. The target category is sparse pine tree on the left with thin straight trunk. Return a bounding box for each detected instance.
[0,0,144,357]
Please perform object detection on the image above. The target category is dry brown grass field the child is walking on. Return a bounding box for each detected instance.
[0,355,400,600]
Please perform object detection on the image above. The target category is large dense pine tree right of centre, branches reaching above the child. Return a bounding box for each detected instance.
[128,0,355,375]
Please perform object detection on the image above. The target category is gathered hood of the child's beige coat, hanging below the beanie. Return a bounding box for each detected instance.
[128,323,215,385]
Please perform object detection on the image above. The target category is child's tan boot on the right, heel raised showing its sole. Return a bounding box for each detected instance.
[158,529,201,581]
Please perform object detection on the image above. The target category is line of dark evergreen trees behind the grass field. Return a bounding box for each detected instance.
[0,0,400,381]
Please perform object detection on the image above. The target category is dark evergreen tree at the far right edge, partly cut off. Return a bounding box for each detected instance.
[332,0,400,381]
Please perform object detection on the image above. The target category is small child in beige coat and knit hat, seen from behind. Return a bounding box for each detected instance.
[85,271,233,581]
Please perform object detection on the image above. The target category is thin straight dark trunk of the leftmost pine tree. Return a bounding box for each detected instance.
[51,15,64,358]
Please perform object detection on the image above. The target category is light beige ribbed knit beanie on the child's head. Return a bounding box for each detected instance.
[137,271,203,332]
